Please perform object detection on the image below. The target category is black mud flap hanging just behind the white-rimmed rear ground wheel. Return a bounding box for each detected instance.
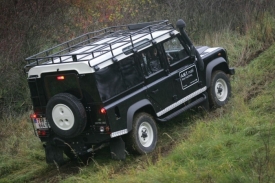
[110,137,126,160]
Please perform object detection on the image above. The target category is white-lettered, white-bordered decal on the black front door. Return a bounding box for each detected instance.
[179,65,199,90]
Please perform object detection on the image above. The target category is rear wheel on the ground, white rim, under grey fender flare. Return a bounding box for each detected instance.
[126,113,157,154]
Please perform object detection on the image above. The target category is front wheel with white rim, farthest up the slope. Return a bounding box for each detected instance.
[208,71,231,107]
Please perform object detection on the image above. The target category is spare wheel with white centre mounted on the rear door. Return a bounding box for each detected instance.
[46,93,87,138]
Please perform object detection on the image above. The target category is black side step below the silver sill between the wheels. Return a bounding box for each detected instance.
[157,94,207,122]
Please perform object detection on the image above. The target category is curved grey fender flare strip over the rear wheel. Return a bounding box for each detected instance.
[127,99,152,132]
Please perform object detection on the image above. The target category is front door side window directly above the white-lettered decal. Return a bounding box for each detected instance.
[163,37,187,65]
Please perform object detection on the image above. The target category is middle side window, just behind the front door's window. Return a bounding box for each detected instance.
[139,46,163,76]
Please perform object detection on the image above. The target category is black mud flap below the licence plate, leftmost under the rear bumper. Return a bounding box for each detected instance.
[44,144,64,165]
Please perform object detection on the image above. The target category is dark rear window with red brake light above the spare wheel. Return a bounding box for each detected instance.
[44,73,82,99]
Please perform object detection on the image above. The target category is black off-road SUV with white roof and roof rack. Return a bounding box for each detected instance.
[24,20,235,163]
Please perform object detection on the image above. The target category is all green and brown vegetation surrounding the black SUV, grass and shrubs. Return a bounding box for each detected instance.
[0,0,275,183]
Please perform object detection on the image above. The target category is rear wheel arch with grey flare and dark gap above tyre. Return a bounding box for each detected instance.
[127,99,155,132]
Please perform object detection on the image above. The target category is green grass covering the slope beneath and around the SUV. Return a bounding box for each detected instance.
[0,21,275,183]
